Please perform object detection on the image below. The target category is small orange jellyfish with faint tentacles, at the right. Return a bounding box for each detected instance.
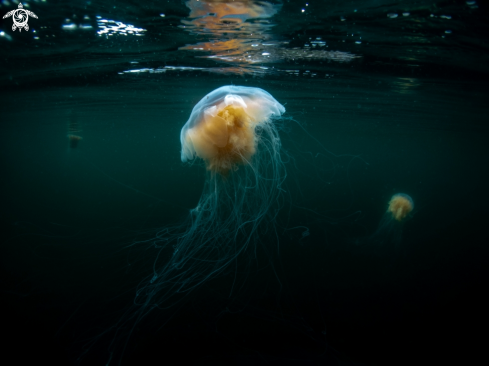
[369,193,414,256]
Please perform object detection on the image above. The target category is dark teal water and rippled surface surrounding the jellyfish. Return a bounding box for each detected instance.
[0,0,489,365]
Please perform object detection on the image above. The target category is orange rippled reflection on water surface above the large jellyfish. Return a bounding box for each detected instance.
[179,0,361,74]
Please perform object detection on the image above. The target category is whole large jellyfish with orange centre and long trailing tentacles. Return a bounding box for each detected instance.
[136,86,286,315]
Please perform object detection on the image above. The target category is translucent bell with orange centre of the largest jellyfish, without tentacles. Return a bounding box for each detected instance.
[180,85,285,175]
